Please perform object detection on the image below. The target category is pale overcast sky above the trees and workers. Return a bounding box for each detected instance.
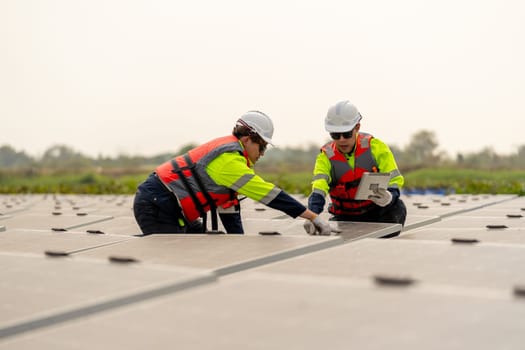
[0,0,525,156]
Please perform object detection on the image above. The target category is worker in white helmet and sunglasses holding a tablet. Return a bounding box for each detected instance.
[304,101,406,237]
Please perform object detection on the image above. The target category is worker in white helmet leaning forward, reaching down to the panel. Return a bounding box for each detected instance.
[133,111,332,235]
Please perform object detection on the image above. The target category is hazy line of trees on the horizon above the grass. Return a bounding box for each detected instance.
[0,130,525,175]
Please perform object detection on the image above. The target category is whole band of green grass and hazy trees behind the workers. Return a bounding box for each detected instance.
[0,130,525,195]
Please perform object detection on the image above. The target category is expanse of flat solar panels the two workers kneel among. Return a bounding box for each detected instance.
[0,195,525,349]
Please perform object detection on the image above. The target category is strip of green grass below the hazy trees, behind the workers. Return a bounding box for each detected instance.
[0,168,525,195]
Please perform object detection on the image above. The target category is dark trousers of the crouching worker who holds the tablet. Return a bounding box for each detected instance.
[330,198,407,238]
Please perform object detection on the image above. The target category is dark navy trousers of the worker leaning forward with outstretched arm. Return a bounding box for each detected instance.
[133,173,202,235]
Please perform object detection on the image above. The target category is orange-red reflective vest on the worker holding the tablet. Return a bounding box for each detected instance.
[321,133,377,215]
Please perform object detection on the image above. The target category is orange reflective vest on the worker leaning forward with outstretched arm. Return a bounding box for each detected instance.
[156,135,248,230]
